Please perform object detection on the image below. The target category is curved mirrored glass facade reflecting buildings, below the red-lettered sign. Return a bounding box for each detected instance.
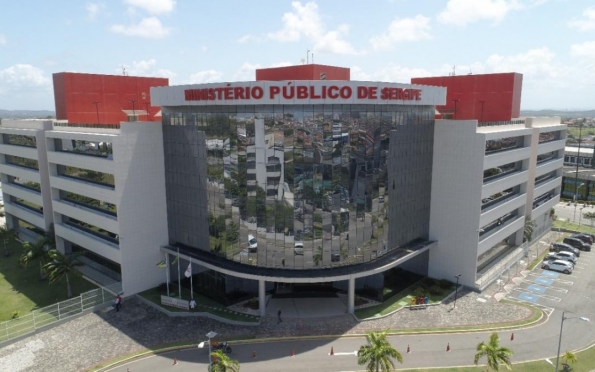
[163,105,434,269]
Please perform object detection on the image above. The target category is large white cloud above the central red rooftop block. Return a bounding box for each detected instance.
[267,1,357,54]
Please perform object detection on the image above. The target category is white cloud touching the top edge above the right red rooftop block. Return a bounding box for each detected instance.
[437,0,520,26]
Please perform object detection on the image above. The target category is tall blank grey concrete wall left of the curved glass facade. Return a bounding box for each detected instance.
[113,122,168,296]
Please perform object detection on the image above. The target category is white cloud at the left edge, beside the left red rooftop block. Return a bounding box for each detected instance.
[0,64,52,95]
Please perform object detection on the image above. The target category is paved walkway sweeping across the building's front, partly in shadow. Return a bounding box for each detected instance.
[0,231,568,372]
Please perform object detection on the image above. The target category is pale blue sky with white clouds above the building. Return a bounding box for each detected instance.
[0,0,595,110]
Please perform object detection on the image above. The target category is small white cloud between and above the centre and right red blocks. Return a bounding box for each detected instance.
[370,15,432,50]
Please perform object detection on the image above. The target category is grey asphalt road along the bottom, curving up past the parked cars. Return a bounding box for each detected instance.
[108,247,595,372]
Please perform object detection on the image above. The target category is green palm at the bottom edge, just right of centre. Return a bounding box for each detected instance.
[357,329,403,372]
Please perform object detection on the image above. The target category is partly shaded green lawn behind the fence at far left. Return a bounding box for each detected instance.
[0,242,97,321]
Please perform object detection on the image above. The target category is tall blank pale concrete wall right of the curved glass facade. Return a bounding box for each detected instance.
[428,120,485,287]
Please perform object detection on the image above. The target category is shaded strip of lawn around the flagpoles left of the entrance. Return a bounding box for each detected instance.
[139,285,259,323]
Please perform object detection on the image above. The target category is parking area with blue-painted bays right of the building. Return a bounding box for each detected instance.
[507,241,595,312]
